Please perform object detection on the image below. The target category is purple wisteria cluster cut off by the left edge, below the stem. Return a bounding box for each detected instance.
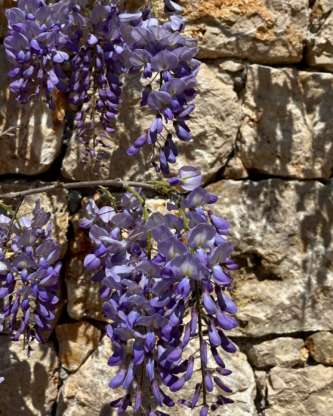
[0,202,61,345]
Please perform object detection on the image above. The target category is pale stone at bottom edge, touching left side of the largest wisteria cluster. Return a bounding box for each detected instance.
[57,337,120,416]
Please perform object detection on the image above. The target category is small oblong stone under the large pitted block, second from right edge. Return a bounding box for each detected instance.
[247,337,308,369]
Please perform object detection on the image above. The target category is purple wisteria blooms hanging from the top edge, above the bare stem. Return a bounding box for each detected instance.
[4,0,199,174]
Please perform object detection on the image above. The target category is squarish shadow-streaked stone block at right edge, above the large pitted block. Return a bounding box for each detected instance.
[238,65,333,178]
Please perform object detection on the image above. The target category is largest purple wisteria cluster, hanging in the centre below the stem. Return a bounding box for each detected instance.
[81,168,237,416]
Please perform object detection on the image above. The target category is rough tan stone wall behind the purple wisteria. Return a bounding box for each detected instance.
[0,0,333,416]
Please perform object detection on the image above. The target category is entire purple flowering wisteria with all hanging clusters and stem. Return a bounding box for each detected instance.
[0,0,237,416]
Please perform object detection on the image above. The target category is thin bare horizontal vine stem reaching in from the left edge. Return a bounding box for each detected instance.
[0,179,167,199]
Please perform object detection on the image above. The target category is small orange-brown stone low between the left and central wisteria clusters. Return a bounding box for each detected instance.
[56,321,102,372]
